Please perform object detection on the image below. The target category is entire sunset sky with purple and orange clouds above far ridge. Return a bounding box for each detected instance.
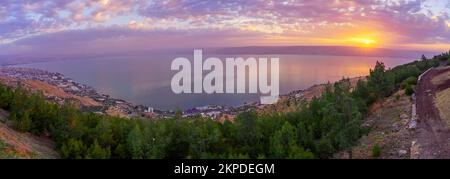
[0,0,450,55]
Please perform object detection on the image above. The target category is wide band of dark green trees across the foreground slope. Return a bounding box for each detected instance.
[0,52,446,159]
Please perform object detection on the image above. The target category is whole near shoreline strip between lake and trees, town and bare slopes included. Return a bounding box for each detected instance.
[0,66,361,121]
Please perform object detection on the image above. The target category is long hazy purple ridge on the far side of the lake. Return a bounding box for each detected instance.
[0,46,437,66]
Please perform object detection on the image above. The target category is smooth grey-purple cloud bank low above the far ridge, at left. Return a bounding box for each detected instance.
[0,27,264,55]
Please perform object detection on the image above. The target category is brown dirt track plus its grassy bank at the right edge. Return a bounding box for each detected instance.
[417,67,450,158]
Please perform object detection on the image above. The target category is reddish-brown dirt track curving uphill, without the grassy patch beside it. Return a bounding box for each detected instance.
[416,68,450,159]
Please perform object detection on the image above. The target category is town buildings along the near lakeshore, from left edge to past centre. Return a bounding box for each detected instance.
[0,67,282,121]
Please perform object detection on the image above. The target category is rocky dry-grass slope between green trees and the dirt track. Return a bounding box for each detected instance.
[335,90,417,159]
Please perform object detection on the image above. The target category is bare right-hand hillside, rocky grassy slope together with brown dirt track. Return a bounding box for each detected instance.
[335,67,450,159]
